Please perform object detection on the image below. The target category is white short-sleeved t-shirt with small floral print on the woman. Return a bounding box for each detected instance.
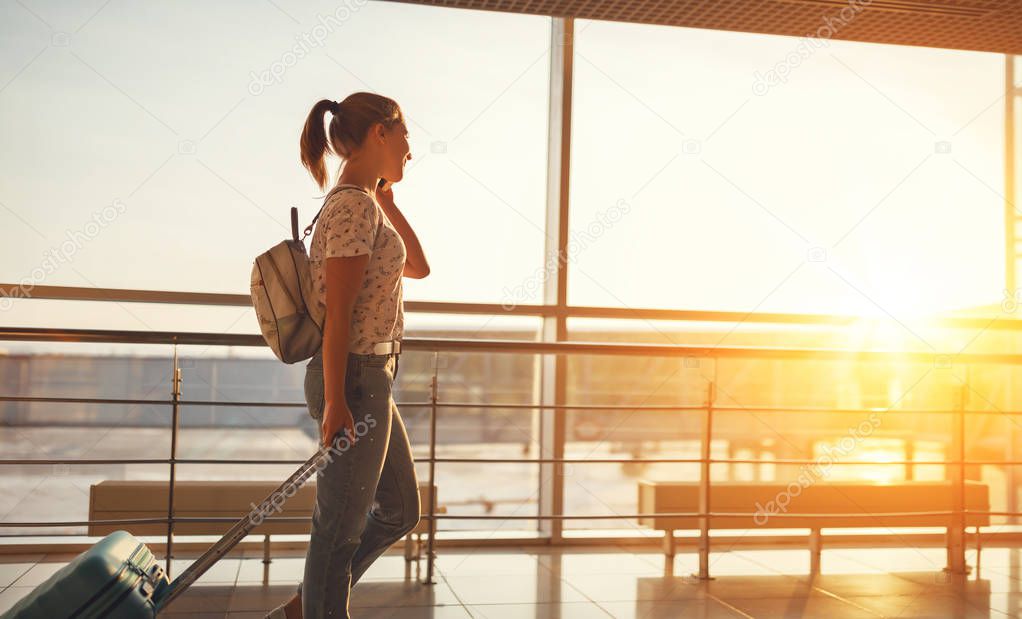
[309,185,407,354]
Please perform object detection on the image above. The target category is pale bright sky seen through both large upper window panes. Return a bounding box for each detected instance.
[0,0,1005,353]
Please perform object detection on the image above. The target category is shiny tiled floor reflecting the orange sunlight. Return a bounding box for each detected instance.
[0,547,1022,619]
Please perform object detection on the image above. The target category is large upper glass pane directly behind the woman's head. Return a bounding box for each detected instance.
[0,2,550,328]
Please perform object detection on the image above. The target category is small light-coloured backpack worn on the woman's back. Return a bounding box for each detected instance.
[250,185,365,364]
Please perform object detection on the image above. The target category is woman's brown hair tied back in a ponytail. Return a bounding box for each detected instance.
[300,92,405,190]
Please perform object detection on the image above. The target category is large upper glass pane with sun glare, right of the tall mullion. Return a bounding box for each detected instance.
[568,20,1004,316]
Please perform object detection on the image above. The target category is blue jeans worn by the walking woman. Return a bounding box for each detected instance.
[298,352,420,619]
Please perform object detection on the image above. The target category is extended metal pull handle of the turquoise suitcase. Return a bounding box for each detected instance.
[156,445,331,613]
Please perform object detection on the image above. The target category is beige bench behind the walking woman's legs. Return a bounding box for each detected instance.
[88,480,447,564]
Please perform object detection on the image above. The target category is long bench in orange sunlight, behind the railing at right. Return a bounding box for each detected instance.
[639,479,990,573]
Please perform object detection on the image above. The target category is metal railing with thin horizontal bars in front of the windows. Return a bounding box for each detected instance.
[0,286,1022,582]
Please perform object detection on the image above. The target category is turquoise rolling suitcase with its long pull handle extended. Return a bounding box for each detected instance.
[0,446,329,619]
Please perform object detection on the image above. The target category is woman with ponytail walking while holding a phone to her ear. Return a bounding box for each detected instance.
[269,92,429,619]
